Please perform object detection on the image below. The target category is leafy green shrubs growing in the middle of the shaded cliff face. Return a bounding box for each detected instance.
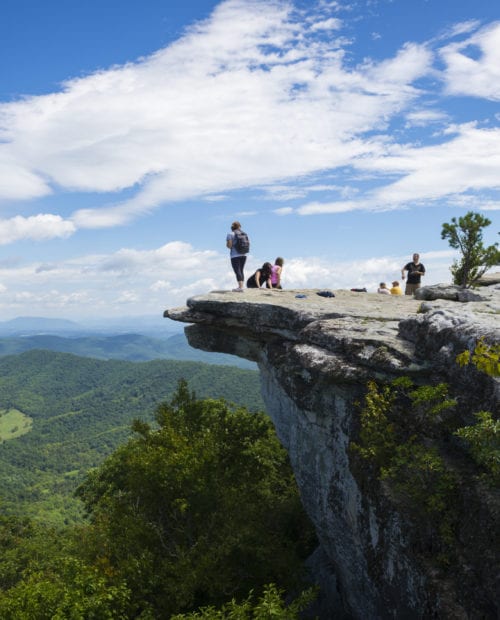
[351,377,457,545]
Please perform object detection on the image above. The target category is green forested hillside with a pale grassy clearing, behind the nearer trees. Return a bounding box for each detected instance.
[0,350,264,524]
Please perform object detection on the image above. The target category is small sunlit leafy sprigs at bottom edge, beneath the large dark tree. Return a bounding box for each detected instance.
[170,584,316,620]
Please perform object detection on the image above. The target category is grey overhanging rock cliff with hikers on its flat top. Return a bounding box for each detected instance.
[165,285,500,620]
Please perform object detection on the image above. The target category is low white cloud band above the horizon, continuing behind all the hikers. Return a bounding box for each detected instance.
[0,242,460,319]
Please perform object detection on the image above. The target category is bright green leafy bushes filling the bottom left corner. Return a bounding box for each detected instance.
[0,517,129,620]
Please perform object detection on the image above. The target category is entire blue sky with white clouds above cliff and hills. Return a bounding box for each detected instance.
[0,0,500,320]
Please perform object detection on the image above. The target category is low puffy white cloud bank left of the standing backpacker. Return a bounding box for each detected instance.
[0,242,229,316]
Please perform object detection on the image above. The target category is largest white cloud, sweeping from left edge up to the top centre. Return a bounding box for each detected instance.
[0,0,431,228]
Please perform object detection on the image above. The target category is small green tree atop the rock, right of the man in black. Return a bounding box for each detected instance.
[441,211,500,288]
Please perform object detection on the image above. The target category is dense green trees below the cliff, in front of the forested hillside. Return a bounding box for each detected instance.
[0,376,316,620]
